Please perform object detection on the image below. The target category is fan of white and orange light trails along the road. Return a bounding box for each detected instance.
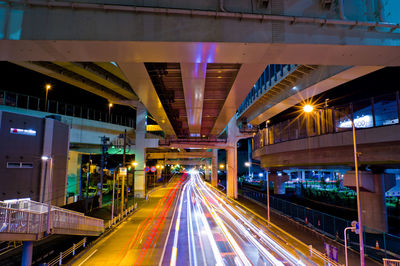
[160,171,332,266]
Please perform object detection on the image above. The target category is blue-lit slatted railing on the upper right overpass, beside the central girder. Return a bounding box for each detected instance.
[236,64,297,117]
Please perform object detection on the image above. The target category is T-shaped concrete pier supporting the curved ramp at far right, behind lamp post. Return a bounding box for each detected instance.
[343,171,396,233]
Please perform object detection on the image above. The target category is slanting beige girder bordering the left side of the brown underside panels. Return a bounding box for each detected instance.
[118,62,176,136]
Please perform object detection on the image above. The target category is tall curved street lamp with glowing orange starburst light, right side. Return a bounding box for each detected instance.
[303,102,365,266]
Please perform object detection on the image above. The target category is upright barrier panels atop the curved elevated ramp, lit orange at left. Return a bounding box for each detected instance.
[254,91,400,150]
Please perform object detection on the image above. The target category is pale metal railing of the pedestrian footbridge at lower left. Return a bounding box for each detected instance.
[0,199,104,237]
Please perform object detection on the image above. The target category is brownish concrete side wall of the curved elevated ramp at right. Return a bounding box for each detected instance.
[253,125,400,167]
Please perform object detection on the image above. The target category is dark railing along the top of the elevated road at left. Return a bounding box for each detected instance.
[0,90,136,128]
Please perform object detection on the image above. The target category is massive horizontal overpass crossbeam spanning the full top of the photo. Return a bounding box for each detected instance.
[0,0,400,65]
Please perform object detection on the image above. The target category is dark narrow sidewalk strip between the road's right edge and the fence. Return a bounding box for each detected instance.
[238,195,382,265]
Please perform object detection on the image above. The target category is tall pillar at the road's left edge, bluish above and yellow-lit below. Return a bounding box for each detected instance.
[134,103,147,198]
